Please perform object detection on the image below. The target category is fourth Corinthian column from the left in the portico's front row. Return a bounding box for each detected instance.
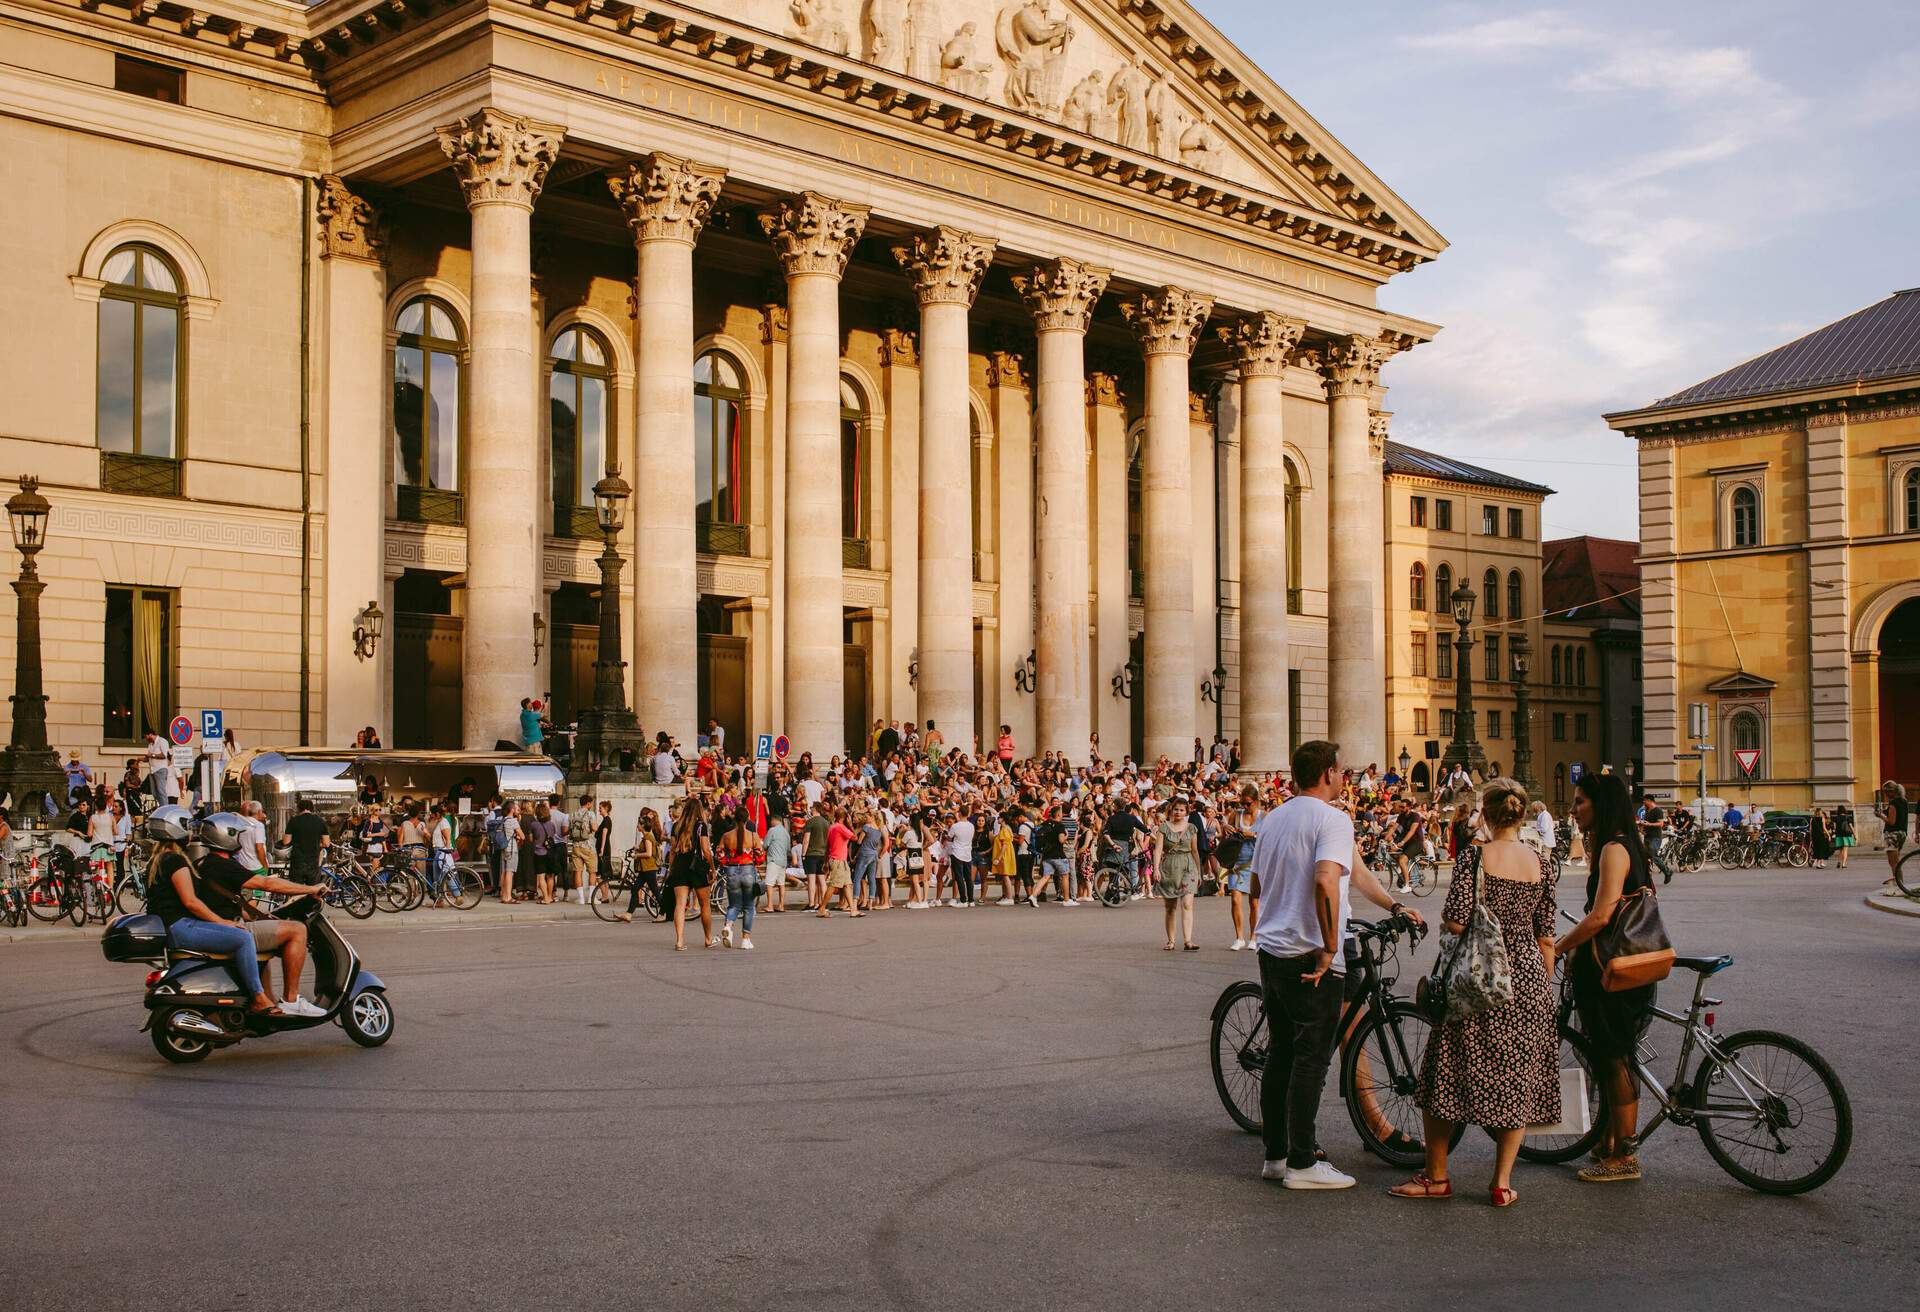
[893,229,995,760]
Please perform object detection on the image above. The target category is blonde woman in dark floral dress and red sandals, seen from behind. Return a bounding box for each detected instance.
[1388,778,1561,1206]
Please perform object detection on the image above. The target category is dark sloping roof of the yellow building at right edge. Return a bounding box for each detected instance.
[1647,288,1920,409]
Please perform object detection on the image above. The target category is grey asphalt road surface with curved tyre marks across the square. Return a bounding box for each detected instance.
[0,870,1920,1312]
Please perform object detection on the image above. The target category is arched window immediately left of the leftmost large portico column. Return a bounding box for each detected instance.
[394,296,467,524]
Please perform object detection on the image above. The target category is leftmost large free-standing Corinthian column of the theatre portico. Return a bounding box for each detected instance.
[432,109,561,751]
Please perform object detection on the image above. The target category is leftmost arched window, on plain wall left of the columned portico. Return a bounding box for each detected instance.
[94,244,186,459]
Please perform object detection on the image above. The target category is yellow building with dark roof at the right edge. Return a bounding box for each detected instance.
[1607,288,1920,807]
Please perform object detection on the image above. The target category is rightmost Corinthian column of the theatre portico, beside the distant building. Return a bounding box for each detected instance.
[1321,336,1394,770]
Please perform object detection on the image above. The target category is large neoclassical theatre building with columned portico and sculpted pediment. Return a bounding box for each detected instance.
[0,0,1444,768]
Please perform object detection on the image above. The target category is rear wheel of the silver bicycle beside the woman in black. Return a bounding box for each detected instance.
[1693,1030,1853,1193]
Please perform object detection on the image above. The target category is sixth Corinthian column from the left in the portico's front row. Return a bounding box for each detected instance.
[1119,286,1213,763]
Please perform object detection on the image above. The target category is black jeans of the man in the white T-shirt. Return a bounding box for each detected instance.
[1260,953,1344,1170]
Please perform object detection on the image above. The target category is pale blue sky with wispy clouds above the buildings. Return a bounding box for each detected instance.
[1196,0,1920,538]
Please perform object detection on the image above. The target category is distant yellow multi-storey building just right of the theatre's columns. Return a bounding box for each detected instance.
[1354,442,1551,788]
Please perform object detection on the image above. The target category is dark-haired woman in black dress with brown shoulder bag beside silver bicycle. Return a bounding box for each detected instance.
[1553,772,1655,1183]
